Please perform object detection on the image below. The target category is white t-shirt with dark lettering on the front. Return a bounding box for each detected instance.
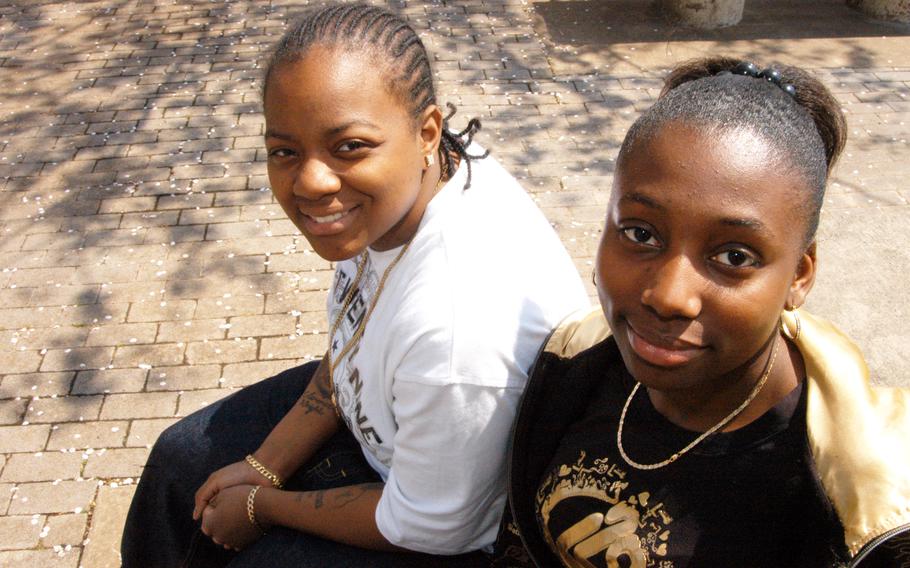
[328,147,589,554]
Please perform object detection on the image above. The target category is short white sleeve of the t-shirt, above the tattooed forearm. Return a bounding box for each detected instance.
[376,380,521,554]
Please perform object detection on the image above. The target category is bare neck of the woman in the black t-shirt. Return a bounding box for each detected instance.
[648,333,802,432]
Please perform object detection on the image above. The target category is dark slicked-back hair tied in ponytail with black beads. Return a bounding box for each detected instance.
[618,57,847,244]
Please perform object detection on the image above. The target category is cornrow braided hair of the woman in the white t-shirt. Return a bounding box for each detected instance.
[262,4,489,189]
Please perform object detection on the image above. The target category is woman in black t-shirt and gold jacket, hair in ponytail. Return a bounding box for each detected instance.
[500,58,910,568]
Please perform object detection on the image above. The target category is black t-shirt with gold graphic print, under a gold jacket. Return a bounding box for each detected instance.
[536,362,835,568]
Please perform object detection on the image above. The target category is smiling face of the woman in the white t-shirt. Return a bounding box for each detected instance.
[265,45,441,260]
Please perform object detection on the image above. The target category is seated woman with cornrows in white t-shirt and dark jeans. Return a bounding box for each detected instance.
[123,5,587,568]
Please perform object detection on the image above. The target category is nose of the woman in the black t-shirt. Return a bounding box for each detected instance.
[641,255,703,319]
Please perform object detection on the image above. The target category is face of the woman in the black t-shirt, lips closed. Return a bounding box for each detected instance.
[597,122,815,400]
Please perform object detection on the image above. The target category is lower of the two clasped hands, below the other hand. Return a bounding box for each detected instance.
[202,485,262,550]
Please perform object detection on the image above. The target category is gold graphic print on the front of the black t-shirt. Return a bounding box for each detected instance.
[537,450,673,568]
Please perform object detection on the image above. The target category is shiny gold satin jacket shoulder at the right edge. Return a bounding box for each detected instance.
[782,310,910,556]
